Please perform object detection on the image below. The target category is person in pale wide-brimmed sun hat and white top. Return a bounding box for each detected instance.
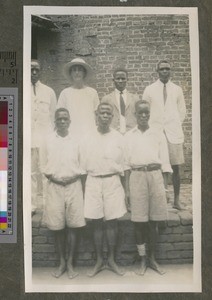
[57,58,99,138]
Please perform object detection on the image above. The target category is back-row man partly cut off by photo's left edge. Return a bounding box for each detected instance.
[31,60,57,213]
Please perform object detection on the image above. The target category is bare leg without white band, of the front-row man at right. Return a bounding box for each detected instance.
[149,221,165,275]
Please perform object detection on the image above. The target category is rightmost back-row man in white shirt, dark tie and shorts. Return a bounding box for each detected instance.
[142,60,186,210]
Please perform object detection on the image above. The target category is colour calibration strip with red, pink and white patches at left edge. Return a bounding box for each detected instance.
[0,88,18,243]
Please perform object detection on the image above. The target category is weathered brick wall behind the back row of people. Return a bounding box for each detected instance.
[33,15,192,182]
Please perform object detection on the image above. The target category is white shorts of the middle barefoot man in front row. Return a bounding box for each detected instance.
[84,175,127,220]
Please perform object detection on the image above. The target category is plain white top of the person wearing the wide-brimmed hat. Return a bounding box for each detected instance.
[57,87,99,138]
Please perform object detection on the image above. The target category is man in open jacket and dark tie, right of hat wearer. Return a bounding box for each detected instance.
[102,68,139,134]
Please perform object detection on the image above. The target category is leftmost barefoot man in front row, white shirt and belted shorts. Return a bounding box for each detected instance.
[41,108,85,279]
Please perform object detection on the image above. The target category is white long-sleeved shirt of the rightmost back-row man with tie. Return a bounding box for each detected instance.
[142,79,186,144]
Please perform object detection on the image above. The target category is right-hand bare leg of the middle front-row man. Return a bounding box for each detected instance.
[106,220,124,276]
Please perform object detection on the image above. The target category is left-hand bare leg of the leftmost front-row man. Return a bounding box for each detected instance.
[52,229,66,278]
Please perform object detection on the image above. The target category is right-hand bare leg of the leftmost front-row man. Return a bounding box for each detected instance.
[67,228,79,279]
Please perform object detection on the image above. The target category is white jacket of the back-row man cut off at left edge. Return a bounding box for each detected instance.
[31,81,57,148]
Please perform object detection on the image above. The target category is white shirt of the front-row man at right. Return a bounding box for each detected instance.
[124,126,172,173]
